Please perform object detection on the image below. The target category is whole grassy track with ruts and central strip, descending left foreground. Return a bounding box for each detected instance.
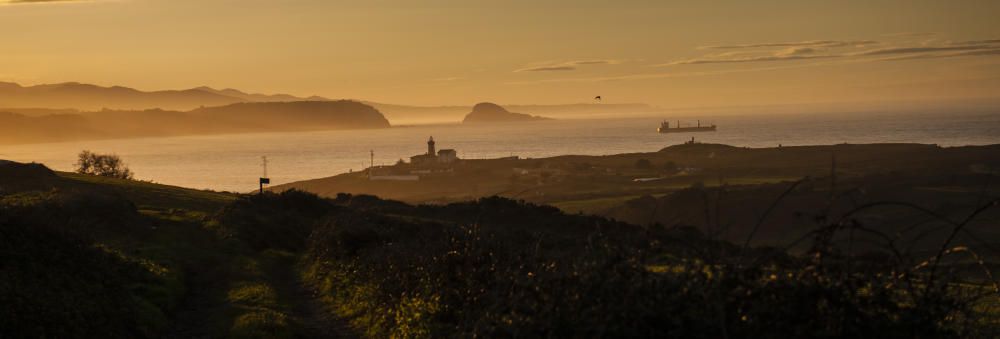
[35,173,354,338]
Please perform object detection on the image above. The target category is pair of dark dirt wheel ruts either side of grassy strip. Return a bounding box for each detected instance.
[159,214,359,338]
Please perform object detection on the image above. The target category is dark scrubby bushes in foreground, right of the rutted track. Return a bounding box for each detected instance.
[298,198,989,338]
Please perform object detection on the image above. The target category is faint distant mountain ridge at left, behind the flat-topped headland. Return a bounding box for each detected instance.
[0,82,336,110]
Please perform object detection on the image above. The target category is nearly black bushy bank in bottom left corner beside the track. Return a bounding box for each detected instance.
[0,215,170,338]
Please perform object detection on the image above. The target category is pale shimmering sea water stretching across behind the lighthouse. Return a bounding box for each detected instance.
[0,112,1000,192]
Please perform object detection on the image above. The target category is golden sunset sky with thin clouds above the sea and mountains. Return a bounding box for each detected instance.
[0,0,1000,107]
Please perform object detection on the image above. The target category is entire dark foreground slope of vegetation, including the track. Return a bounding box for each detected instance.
[0,163,1000,338]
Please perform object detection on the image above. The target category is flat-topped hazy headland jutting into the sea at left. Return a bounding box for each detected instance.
[0,100,389,144]
